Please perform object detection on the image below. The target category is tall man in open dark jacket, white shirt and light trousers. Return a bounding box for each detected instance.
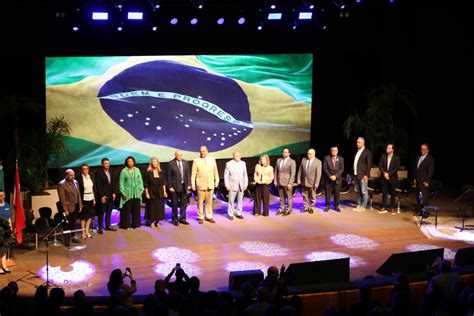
[352,137,372,212]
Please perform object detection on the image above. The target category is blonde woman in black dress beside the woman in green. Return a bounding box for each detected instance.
[145,157,168,227]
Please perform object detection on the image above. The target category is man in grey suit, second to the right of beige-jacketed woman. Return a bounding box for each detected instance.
[297,148,322,214]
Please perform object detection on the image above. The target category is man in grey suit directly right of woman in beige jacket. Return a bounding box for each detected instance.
[273,147,296,216]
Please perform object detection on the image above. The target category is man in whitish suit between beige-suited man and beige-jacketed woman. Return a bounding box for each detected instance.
[224,151,249,220]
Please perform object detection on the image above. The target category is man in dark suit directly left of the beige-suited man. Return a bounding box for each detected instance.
[167,150,191,226]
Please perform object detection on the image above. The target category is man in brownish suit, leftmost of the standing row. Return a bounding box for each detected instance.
[58,169,82,247]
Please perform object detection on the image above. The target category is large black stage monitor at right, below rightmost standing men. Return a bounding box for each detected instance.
[377,248,444,276]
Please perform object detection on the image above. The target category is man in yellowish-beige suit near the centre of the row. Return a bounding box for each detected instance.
[191,146,219,224]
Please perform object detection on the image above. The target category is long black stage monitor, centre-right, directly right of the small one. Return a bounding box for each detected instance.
[285,258,350,285]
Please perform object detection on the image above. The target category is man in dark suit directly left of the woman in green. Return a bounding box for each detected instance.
[94,158,118,234]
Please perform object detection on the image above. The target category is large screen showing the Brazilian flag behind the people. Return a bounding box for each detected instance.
[46,54,313,166]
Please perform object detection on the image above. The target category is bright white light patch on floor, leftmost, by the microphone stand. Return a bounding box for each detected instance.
[38,260,95,285]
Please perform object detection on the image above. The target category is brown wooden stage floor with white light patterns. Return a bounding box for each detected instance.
[0,194,472,296]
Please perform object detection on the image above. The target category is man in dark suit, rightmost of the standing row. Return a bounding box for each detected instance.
[413,144,434,210]
